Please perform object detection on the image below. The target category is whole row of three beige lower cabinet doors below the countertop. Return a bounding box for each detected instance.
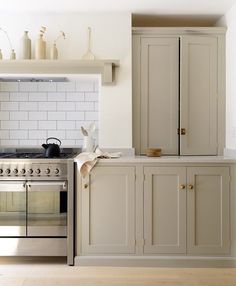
[79,164,230,257]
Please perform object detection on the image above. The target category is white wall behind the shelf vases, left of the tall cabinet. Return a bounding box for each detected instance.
[0,13,132,148]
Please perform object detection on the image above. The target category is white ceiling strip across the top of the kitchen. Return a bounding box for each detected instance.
[0,0,236,15]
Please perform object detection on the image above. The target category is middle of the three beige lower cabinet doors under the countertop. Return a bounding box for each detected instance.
[144,167,186,254]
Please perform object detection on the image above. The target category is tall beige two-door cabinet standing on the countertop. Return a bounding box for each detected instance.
[133,28,225,155]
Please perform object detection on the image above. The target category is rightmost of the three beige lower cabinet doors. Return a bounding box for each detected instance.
[187,167,230,255]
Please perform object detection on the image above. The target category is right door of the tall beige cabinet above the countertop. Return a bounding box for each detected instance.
[180,36,218,155]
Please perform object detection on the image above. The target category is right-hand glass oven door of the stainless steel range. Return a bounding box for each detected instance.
[26,181,67,237]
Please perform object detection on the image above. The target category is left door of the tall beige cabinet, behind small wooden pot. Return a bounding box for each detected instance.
[140,37,179,154]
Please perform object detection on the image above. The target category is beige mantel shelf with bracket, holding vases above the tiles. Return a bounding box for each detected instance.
[0,60,119,85]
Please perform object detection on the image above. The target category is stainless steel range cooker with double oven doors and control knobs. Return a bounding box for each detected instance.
[0,150,76,265]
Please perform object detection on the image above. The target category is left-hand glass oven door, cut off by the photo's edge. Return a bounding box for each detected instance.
[0,181,26,237]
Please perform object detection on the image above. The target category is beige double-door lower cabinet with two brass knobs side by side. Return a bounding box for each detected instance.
[144,167,230,255]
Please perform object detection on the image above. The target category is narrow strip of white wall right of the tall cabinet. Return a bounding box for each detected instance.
[217,4,236,149]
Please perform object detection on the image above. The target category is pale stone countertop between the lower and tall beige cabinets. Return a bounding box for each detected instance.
[74,156,236,164]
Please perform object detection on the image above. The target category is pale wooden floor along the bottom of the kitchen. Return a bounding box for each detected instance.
[0,260,236,286]
